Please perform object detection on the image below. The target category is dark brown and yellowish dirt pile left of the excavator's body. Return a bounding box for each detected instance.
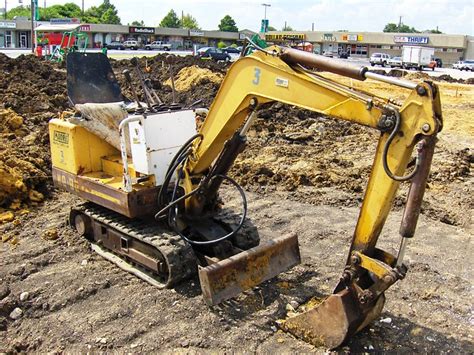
[0,54,68,212]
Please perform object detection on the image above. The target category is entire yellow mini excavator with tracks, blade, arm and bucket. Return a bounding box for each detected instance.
[49,41,442,348]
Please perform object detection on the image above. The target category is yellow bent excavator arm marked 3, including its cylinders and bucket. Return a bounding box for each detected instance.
[176,47,442,348]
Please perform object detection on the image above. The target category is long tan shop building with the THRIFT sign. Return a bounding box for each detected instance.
[265,31,474,64]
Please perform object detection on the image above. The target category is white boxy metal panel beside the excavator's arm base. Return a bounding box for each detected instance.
[129,110,196,186]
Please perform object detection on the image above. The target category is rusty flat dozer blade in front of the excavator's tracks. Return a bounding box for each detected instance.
[199,234,301,305]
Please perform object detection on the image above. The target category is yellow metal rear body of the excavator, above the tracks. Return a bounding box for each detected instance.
[49,119,157,217]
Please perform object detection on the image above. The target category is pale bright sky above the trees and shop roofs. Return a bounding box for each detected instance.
[14,0,474,35]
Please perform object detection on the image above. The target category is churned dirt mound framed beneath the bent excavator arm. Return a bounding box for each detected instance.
[232,103,376,205]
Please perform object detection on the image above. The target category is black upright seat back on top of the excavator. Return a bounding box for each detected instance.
[66,52,128,105]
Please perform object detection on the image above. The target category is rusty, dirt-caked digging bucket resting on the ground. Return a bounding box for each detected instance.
[280,289,385,349]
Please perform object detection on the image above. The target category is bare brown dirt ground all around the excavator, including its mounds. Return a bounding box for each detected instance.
[0,55,474,353]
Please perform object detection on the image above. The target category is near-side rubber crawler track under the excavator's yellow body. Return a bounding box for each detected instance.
[73,202,197,288]
